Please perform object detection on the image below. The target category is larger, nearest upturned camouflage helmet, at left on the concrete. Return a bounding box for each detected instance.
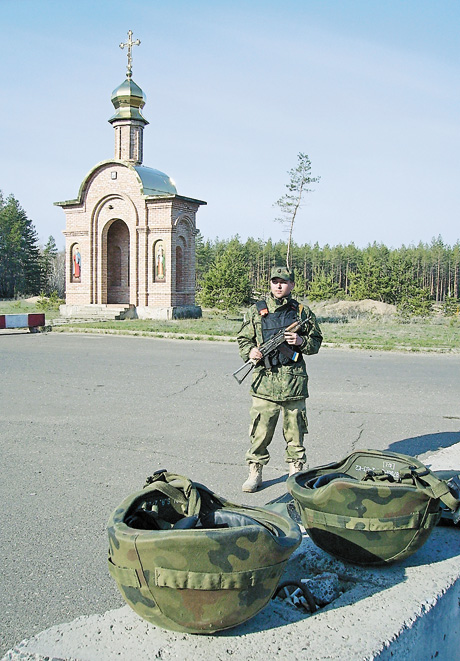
[108,471,301,633]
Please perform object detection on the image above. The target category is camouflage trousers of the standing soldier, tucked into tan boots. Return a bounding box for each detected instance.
[246,397,308,466]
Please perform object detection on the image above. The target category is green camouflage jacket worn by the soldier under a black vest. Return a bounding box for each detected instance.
[237,294,323,402]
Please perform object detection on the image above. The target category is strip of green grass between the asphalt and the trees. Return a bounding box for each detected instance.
[0,300,460,352]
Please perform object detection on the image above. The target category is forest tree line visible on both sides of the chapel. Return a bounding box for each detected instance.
[0,191,460,313]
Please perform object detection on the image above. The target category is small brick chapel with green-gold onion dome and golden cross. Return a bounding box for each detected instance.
[55,30,206,319]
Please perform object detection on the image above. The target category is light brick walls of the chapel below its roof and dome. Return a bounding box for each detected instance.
[59,161,199,308]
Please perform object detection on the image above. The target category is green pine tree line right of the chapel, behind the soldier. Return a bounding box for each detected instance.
[196,234,460,312]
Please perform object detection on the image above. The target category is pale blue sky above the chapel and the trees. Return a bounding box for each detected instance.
[0,0,460,247]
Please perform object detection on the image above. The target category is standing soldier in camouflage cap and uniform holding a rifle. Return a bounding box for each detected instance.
[237,266,323,493]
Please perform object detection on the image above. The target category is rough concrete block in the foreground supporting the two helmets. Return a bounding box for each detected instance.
[2,445,460,661]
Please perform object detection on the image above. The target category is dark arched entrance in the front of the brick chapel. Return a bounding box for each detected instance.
[107,220,130,305]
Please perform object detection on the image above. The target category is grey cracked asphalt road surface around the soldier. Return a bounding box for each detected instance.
[0,332,460,654]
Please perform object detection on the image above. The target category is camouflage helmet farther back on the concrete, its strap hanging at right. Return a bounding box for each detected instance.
[287,450,460,565]
